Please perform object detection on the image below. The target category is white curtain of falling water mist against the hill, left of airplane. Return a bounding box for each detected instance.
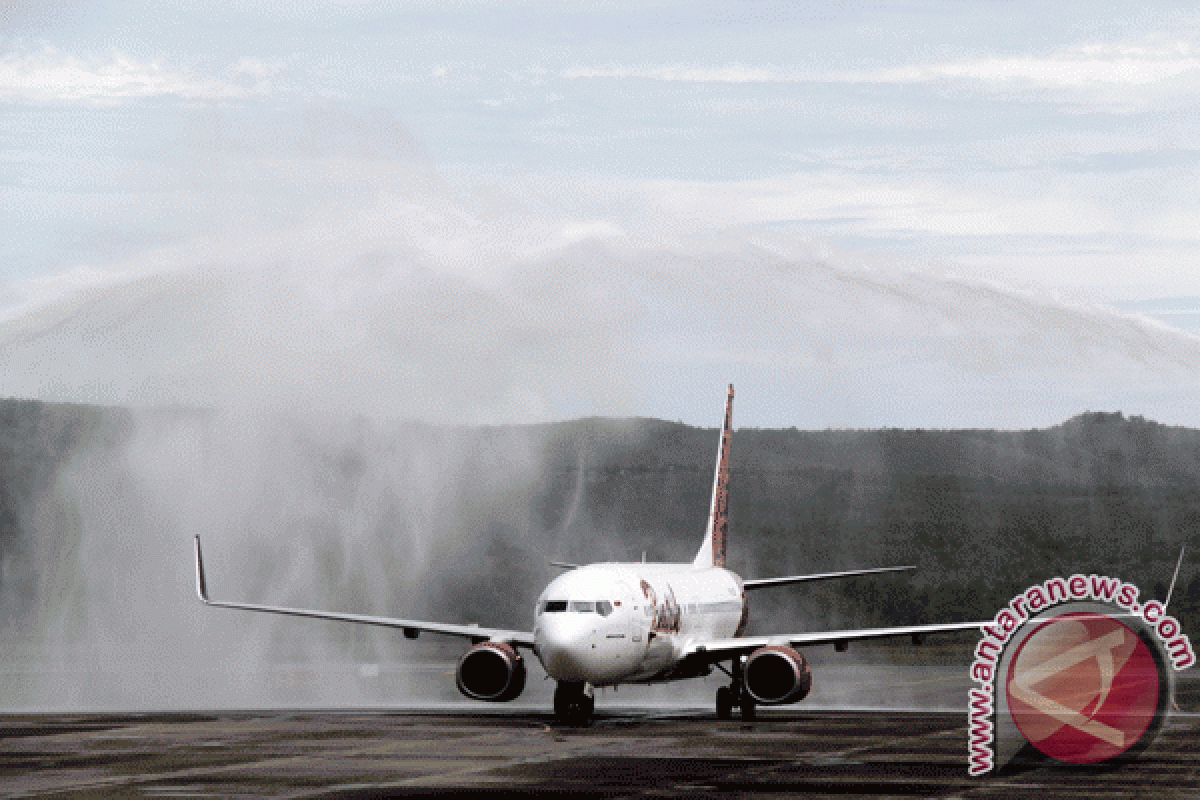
[2,411,542,709]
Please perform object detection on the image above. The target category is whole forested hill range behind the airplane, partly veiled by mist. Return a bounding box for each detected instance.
[0,401,1200,652]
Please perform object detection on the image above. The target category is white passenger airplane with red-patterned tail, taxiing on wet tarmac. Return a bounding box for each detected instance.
[196,385,980,726]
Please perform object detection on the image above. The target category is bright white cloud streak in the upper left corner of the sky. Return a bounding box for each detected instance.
[0,44,280,106]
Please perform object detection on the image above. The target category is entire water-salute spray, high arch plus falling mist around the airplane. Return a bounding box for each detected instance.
[9,209,1200,709]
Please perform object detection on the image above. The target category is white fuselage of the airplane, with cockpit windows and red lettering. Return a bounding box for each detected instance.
[533,564,745,686]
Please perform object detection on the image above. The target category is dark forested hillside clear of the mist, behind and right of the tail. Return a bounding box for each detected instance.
[535,413,1200,624]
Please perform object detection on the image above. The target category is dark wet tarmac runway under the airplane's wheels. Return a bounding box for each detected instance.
[0,706,1200,799]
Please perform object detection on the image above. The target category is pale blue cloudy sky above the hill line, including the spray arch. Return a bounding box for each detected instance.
[0,1,1200,427]
